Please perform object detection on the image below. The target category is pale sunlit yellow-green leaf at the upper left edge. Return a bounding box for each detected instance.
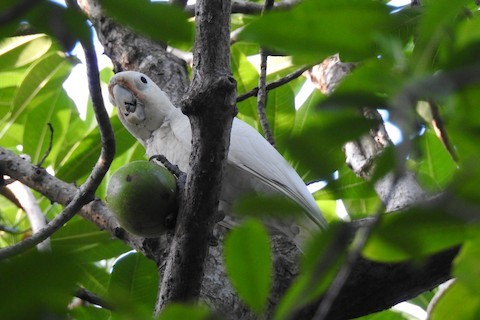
[0,34,52,71]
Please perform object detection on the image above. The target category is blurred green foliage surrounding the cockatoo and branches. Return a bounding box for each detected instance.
[0,0,480,320]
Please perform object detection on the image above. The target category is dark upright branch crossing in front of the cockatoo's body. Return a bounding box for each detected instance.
[156,0,235,312]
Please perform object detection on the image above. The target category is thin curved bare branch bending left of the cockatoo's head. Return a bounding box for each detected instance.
[0,13,115,260]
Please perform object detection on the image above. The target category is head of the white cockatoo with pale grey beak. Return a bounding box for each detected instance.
[108,71,175,142]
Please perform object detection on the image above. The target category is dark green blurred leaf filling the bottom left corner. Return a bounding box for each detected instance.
[0,251,79,320]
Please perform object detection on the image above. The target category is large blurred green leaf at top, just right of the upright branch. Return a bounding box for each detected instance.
[239,0,394,62]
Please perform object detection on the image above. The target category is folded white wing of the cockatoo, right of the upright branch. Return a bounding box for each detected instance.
[228,119,327,228]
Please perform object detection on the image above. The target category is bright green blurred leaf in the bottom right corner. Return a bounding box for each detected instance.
[429,281,480,320]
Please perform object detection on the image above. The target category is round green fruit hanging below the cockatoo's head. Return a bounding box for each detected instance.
[106,161,177,237]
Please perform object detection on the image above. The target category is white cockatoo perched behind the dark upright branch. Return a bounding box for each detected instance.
[108,71,327,245]
